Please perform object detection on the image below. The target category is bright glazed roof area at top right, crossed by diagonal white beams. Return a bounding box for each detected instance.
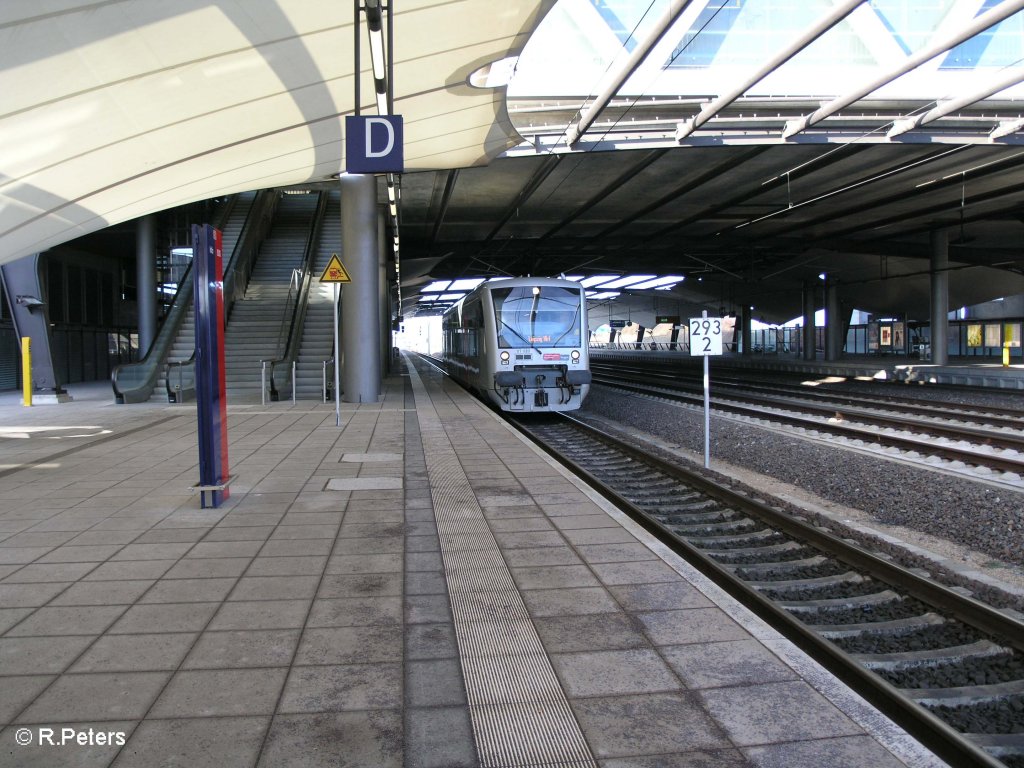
[508,0,1024,116]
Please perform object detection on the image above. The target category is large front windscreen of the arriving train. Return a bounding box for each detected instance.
[490,286,581,348]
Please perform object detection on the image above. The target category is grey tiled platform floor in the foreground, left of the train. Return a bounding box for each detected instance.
[0,362,942,768]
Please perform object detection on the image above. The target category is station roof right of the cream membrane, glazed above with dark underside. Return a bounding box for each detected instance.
[402,0,1024,319]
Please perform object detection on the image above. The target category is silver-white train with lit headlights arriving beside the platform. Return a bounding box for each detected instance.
[441,278,591,413]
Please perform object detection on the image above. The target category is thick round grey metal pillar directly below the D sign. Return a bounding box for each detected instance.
[340,174,381,402]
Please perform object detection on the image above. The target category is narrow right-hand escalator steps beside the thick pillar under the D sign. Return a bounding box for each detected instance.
[295,190,341,400]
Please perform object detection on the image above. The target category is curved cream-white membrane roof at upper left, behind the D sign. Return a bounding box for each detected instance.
[0,0,553,262]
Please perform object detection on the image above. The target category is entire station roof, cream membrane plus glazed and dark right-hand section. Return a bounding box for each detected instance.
[0,0,1024,316]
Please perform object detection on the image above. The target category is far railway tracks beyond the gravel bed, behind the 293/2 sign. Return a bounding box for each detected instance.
[593,366,1024,486]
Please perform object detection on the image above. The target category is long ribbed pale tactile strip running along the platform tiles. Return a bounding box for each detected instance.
[409,366,597,768]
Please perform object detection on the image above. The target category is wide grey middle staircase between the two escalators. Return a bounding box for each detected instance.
[224,195,318,401]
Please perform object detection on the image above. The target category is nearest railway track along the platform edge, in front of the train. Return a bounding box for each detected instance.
[517,417,1024,768]
